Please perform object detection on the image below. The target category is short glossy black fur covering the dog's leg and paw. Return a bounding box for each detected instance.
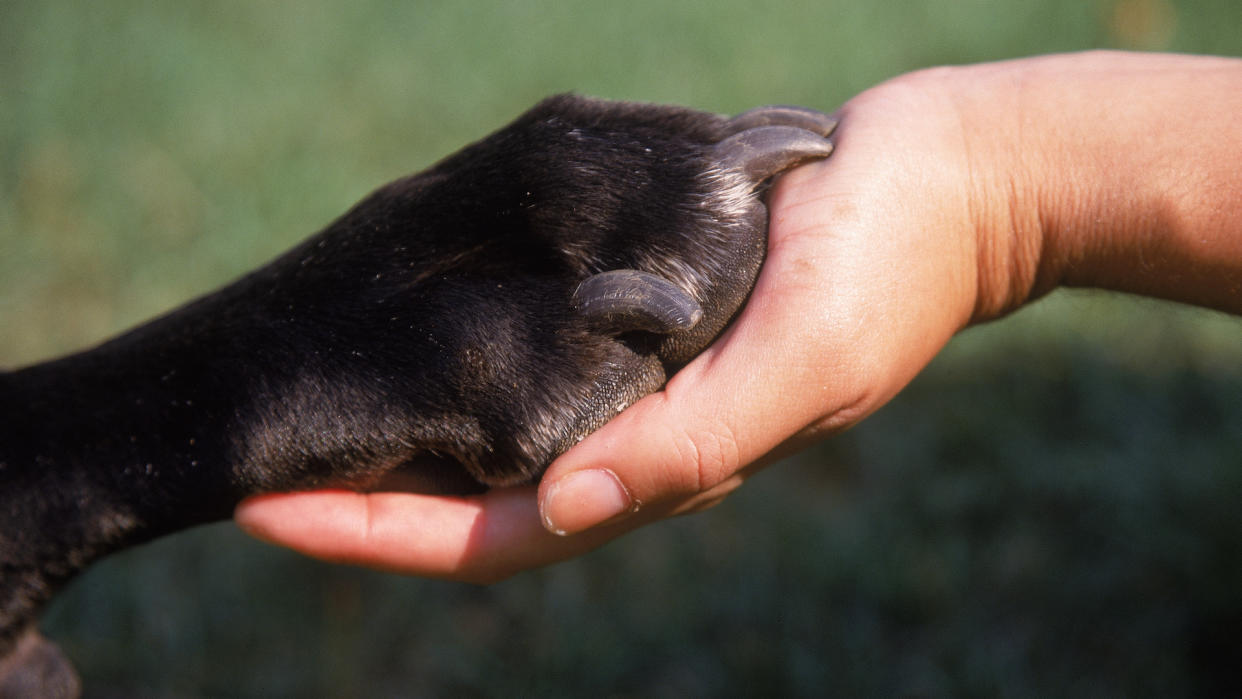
[0,96,826,687]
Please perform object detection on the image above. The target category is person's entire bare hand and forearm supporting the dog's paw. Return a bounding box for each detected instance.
[236,52,1242,582]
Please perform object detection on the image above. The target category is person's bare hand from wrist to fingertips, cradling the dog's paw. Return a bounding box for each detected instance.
[237,65,998,580]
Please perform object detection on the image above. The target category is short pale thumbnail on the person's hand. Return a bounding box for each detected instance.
[540,468,637,536]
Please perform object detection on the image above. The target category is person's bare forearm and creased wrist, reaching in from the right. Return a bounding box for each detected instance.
[938,52,1242,320]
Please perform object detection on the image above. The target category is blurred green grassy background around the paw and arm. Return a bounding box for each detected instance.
[0,0,1242,698]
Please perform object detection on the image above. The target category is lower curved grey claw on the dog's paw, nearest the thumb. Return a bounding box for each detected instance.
[573,269,703,334]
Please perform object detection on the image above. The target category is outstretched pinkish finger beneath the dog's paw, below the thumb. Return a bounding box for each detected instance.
[235,487,623,582]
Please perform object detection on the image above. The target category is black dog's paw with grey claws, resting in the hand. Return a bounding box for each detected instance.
[233,96,835,485]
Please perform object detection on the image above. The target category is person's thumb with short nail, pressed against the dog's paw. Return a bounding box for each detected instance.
[539,284,825,534]
